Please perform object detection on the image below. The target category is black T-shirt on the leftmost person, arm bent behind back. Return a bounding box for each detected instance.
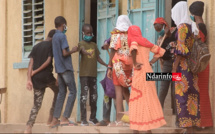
[28,41,55,89]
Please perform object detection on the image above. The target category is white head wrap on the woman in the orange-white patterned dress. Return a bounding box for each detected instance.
[115,15,132,32]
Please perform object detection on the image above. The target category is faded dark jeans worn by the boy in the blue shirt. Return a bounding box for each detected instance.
[54,71,77,118]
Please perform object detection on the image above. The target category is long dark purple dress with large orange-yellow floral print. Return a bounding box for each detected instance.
[175,24,201,127]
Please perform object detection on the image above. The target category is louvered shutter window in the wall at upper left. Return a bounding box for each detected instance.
[22,0,44,59]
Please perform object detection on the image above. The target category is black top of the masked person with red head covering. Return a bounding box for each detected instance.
[161,29,178,60]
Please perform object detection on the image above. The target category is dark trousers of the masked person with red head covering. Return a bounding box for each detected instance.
[158,60,176,113]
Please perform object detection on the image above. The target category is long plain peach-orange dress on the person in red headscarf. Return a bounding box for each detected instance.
[129,42,166,131]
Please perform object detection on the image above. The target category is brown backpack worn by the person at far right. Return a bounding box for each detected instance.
[188,38,211,74]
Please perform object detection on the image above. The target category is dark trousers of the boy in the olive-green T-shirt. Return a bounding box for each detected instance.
[80,77,98,121]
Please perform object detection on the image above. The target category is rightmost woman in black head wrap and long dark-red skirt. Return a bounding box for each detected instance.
[189,1,213,127]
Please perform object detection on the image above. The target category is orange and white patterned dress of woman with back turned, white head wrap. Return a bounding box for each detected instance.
[110,30,133,87]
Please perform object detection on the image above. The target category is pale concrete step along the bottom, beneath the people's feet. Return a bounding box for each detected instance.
[0,124,184,134]
